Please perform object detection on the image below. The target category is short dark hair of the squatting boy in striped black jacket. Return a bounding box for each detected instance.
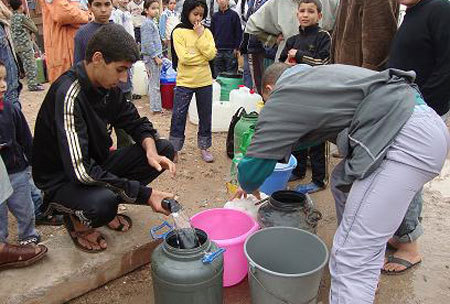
[85,23,140,63]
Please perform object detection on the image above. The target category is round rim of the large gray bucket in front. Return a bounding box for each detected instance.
[244,227,330,278]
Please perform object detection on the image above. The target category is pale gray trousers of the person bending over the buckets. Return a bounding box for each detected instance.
[329,106,450,304]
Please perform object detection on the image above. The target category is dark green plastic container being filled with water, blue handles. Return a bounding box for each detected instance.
[151,229,223,304]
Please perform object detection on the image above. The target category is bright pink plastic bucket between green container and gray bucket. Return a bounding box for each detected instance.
[191,208,259,287]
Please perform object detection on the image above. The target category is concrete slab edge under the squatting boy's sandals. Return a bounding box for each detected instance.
[0,206,162,304]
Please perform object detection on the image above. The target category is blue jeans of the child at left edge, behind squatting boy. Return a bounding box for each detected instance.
[0,169,40,243]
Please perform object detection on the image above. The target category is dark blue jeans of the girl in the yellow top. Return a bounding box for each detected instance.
[169,85,212,151]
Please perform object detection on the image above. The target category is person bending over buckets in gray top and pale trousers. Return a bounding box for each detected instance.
[236,63,450,303]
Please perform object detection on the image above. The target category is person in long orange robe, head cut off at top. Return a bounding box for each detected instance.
[39,0,89,82]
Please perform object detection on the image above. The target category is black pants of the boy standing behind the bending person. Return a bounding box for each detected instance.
[292,143,326,187]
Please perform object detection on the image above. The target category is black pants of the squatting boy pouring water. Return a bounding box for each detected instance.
[45,140,174,228]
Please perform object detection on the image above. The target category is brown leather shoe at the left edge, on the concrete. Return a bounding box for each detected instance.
[0,243,48,269]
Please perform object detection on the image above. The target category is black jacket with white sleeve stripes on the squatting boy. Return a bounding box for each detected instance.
[32,62,157,204]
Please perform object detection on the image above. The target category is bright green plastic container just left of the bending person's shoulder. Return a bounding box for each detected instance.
[234,112,258,155]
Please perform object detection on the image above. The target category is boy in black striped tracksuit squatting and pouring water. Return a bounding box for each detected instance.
[32,24,175,252]
